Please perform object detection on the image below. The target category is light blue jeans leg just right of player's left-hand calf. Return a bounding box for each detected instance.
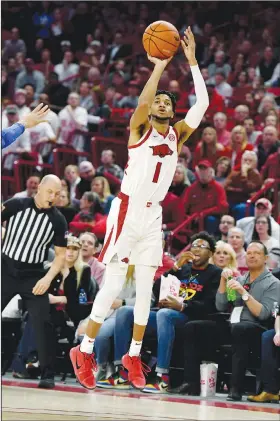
[94,317,116,365]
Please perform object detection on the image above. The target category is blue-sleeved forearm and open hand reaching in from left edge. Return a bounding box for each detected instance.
[1,104,49,149]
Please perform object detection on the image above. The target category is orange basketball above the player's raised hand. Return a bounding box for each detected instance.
[142,20,180,60]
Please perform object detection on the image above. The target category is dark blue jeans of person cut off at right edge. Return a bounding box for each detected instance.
[261,329,280,395]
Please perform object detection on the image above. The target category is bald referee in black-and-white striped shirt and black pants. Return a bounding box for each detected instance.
[1,175,67,389]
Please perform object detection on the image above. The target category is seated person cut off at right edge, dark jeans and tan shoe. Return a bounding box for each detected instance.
[248,298,280,403]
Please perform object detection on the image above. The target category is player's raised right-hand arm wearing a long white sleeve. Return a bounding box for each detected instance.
[174,27,209,146]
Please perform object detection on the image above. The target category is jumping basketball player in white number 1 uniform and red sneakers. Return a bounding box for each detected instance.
[70,27,209,389]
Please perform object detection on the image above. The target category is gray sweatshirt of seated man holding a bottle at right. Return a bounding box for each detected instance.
[216,269,280,325]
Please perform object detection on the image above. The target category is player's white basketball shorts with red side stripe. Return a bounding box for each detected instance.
[99,193,163,266]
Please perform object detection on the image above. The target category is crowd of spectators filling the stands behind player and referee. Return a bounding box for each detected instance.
[2,1,280,402]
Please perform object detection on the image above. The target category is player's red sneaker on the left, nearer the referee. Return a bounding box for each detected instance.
[70,345,97,390]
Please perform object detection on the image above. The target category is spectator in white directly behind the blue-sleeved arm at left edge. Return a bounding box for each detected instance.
[2,104,31,170]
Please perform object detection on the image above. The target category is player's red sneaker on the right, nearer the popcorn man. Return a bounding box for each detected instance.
[122,353,151,390]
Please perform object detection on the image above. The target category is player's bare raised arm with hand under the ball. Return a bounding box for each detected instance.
[130,55,173,130]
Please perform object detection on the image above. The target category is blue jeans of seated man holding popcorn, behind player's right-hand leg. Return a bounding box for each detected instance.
[114,306,188,373]
